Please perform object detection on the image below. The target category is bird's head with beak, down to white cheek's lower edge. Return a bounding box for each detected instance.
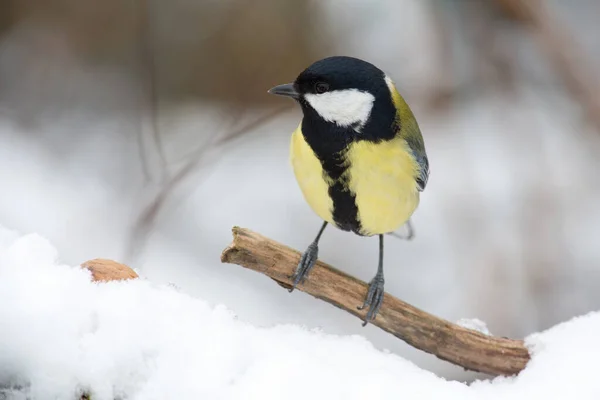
[269,56,396,131]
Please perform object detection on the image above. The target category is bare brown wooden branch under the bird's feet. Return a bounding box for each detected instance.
[221,227,529,375]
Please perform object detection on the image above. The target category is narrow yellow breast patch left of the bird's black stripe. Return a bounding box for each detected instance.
[290,126,333,223]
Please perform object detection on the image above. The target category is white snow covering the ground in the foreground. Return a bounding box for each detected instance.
[0,229,600,400]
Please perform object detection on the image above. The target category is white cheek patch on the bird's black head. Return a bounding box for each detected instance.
[304,89,375,131]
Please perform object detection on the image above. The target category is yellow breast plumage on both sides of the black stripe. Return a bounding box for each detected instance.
[290,126,419,236]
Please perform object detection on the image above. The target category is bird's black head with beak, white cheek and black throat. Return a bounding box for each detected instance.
[269,56,401,145]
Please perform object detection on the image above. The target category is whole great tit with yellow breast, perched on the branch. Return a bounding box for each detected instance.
[269,56,429,325]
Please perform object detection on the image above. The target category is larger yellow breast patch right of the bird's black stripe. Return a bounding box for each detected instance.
[347,138,419,235]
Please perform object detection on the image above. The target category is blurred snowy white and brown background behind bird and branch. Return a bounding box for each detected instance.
[0,0,600,380]
